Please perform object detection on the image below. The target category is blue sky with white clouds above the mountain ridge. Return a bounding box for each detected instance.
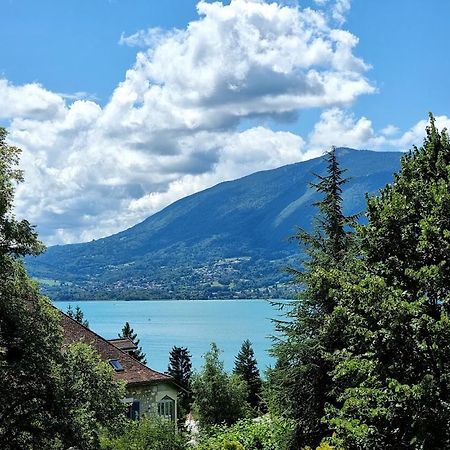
[0,0,450,245]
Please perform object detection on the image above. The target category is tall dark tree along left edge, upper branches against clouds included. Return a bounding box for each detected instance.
[0,128,61,449]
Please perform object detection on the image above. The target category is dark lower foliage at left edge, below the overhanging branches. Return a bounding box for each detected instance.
[0,256,62,450]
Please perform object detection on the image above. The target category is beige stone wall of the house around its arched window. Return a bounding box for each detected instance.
[127,383,178,417]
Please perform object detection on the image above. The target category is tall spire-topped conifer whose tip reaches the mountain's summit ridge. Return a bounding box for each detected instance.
[266,147,356,447]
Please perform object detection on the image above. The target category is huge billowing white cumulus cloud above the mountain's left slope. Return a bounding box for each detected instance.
[5,0,378,243]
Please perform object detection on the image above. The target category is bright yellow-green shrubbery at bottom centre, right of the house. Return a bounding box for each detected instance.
[197,416,295,450]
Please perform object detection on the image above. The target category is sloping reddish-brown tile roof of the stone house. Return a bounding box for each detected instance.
[60,311,175,385]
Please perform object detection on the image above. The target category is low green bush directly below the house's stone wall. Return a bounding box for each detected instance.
[101,417,187,450]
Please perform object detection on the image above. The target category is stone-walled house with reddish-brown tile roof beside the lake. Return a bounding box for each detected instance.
[61,312,181,422]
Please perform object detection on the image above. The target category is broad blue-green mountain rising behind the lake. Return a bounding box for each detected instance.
[26,148,401,300]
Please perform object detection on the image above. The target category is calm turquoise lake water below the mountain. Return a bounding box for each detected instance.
[55,300,279,372]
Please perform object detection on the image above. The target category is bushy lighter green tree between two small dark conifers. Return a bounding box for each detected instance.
[192,343,248,426]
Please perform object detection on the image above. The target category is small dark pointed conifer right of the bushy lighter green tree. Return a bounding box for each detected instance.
[234,339,262,409]
